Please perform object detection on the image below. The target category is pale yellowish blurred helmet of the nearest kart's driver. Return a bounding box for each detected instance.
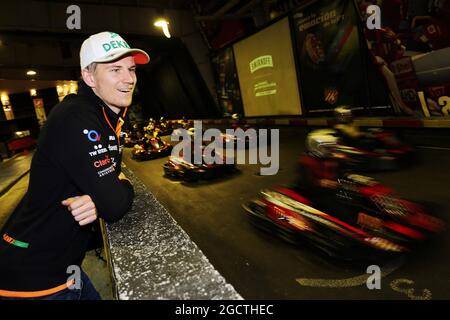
[306,129,338,158]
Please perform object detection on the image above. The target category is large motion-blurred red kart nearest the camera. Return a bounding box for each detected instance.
[243,174,444,260]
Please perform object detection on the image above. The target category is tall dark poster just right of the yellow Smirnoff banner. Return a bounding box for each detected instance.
[294,0,370,115]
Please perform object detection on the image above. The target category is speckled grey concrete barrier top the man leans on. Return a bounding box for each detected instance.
[104,167,242,300]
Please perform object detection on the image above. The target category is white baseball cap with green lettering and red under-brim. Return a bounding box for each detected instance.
[80,31,150,69]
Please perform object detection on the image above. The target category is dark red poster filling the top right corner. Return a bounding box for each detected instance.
[356,0,450,117]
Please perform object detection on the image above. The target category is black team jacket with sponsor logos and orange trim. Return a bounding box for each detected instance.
[0,81,134,296]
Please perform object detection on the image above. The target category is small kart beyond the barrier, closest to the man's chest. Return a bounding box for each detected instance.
[131,135,172,161]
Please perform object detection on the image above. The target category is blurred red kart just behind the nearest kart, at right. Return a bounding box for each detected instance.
[319,129,415,171]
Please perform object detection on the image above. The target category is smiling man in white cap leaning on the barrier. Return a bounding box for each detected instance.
[0,32,149,299]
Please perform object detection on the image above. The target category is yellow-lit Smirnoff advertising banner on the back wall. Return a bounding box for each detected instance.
[233,18,302,117]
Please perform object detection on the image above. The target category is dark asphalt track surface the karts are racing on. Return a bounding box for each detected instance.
[124,129,450,300]
